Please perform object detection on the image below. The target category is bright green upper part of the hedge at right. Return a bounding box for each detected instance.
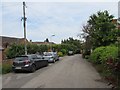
[90,45,118,64]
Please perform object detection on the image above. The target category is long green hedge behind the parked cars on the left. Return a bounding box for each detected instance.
[5,43,77,59]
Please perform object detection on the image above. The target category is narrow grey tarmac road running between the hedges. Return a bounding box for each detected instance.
[3,54,107,88]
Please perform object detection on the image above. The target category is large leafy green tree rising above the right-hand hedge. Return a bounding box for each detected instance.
[83,11,117,48]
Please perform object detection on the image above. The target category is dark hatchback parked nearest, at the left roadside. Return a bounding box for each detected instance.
[12,54,48,72]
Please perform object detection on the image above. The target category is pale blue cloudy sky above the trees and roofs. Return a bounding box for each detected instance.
[0,0,118,43]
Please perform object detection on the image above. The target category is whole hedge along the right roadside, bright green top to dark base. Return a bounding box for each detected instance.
[89,45,120,87]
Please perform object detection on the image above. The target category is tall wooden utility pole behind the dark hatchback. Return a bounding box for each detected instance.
[22,2,27,55]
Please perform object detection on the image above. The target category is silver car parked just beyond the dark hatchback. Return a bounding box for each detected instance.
[43,52,59,63]
